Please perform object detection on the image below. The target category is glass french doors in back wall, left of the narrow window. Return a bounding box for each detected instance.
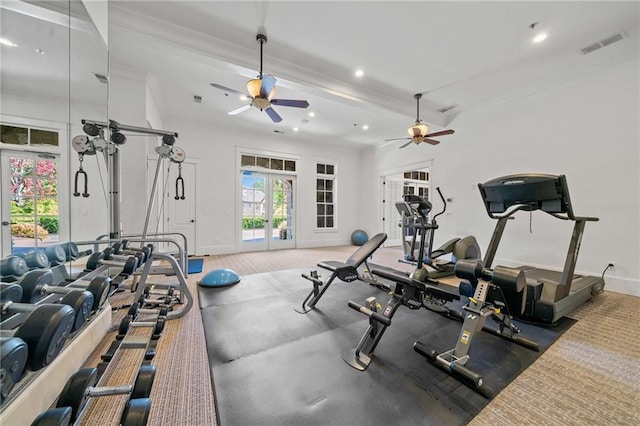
[240,171,296,251]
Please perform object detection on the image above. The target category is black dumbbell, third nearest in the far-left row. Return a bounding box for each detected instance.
[17,269,92,331]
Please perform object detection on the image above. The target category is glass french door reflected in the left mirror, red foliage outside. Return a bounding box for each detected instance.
[0,150,60,257]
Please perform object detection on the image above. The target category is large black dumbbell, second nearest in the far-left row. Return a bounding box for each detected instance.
[0,283,75,371]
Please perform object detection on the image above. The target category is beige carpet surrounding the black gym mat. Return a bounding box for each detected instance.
[81,246,640,426]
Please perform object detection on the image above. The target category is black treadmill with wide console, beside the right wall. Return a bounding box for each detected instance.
[478,174,604,324]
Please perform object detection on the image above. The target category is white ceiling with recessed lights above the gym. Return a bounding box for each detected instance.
[2,0,640,145]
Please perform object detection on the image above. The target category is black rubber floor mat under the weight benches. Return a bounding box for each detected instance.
[199,270,574,426]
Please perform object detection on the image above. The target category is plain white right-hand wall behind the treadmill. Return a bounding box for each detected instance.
[361,59,640,295]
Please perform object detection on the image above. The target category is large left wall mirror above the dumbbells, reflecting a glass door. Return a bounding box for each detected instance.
[0,0,109,258]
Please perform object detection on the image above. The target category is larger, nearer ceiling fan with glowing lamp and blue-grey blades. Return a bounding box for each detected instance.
[211,34,309,123]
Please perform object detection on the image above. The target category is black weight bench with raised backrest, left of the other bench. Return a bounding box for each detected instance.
[294,232,389,314]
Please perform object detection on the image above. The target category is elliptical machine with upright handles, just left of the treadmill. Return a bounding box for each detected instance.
[396,187,482,281]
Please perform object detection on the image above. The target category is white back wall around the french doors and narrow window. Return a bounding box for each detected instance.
[162,117,362,254]
